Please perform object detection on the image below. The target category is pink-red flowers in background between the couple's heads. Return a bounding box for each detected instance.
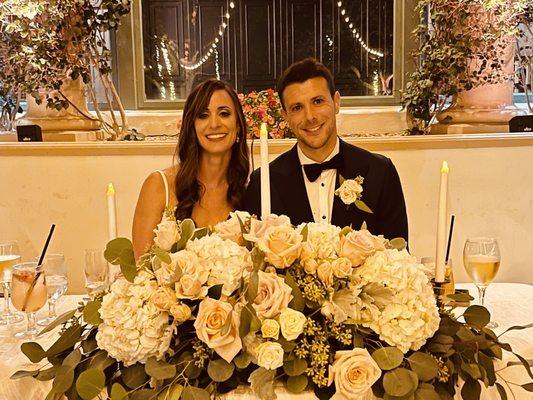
[239,89,294,139]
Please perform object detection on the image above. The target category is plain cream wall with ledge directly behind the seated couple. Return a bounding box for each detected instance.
[0,134,533,296]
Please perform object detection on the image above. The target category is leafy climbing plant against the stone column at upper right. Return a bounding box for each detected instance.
[402,0,528,134]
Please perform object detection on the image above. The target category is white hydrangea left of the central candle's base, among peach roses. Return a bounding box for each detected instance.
[186,234,252,296]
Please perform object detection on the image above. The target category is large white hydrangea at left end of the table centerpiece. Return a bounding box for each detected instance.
[96,271,174,366]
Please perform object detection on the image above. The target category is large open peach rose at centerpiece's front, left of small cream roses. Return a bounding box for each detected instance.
[194,297,242,363]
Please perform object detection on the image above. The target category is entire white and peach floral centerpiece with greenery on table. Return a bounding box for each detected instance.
[13,212,533,400]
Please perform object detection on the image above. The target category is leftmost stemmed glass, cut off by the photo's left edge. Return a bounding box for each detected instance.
[0,241,24,325]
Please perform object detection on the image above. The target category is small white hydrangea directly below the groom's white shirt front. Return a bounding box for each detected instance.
[297,222,341,260]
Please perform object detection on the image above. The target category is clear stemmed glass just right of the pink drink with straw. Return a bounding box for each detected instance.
[37,254,67,326]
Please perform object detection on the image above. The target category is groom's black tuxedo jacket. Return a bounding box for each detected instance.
[244,140,408,241]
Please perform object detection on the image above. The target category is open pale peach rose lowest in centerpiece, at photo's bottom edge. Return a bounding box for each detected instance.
[328,348,381,400]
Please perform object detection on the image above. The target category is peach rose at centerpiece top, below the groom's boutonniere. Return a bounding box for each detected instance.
[337,229,385,267]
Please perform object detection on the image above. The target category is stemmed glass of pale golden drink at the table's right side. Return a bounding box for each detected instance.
[463,237,500,329]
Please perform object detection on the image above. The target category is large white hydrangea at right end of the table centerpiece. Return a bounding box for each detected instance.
[354,249,440,353]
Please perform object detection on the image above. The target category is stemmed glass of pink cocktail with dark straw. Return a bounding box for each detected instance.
[11,261,47,339]
